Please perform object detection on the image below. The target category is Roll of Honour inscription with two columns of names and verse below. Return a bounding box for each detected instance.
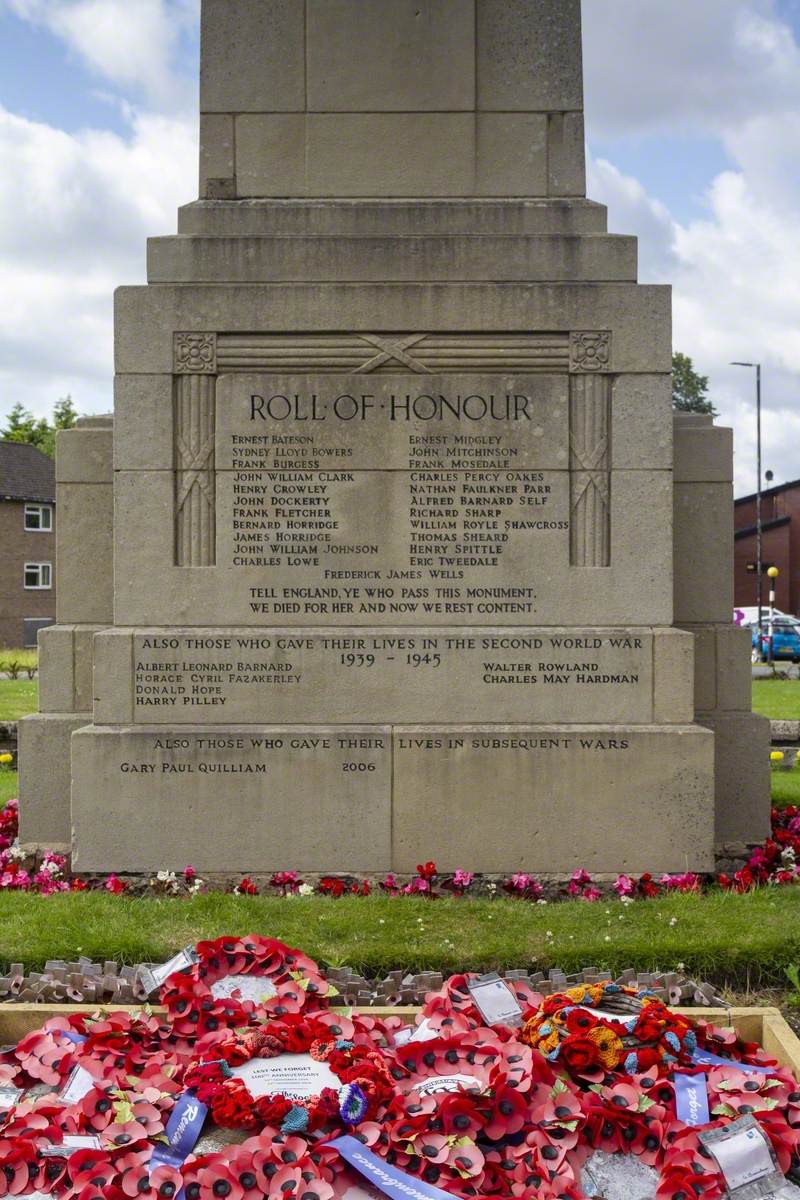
[215,374,607,624]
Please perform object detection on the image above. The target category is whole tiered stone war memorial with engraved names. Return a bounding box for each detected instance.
[20,0,769,875]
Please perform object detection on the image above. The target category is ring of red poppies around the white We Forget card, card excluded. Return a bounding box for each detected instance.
[184,1013,393,1135]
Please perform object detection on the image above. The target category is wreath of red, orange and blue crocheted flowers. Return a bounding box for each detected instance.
[521,983,698,1081]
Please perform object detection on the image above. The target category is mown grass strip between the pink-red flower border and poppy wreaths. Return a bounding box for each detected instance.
[0,888,800,990]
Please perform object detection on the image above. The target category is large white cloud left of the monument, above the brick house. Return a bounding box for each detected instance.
[0,109,197,415]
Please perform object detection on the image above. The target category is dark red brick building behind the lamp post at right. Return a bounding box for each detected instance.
[734,479,800,616]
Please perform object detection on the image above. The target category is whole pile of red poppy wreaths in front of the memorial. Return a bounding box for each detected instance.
[0,935,800,1200]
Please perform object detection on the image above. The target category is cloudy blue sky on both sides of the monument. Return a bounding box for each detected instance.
[0,0,800,492]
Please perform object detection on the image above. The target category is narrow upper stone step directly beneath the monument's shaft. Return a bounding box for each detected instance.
[178,199,608,238]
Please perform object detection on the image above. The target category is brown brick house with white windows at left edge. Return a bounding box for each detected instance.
[0,442,55,648]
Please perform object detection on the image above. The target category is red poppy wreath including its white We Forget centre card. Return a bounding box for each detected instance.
[184,1014,393,1134]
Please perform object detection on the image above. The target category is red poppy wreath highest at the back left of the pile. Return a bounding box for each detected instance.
[161,934,338,1039]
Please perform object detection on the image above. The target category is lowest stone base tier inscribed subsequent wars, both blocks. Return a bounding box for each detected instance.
[72,725,714,875]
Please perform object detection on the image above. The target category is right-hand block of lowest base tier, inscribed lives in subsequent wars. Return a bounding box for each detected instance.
[392,725,714,875]
